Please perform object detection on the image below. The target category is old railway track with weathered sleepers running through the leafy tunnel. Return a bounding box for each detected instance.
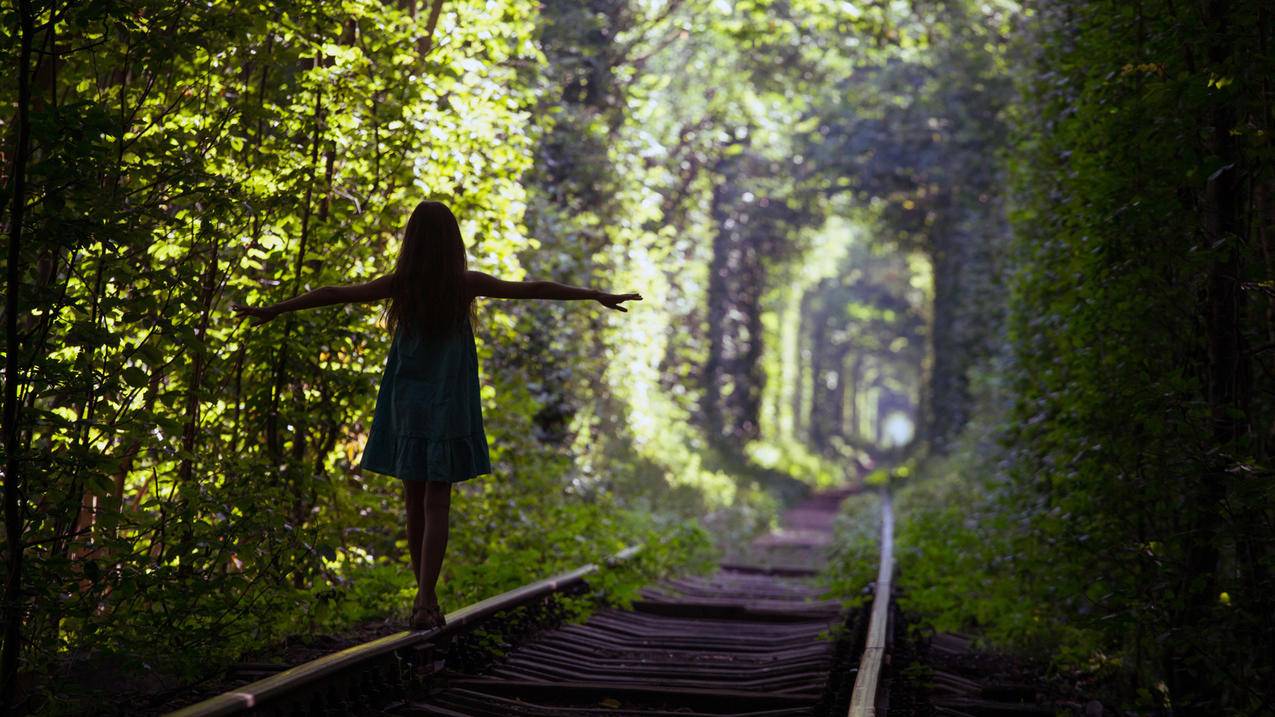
[164,482,893,717]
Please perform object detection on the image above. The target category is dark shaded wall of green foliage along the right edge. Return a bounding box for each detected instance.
[1007,3,1275,713]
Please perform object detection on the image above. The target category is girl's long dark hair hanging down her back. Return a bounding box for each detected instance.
[385,202,473,337]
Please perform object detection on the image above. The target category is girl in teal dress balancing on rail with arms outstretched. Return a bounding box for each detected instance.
[232,202,641,630]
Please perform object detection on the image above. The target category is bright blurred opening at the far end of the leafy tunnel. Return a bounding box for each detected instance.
[748,209,931,469]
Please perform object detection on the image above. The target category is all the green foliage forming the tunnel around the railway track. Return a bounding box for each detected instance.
[22,0,1275,713]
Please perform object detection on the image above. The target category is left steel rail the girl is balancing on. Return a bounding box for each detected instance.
[166,545,641,717]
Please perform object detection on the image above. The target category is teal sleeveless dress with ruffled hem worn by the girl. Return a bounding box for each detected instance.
[360,318,491,482]
